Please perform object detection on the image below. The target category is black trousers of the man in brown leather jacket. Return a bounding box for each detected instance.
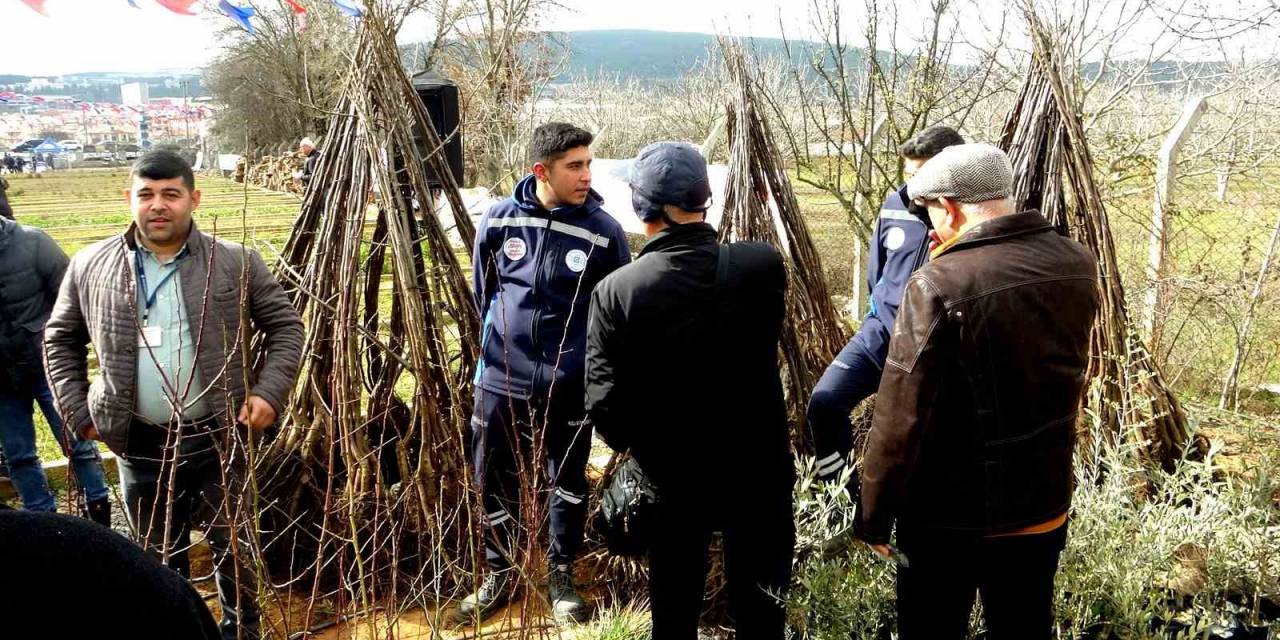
[897,525,1068,640]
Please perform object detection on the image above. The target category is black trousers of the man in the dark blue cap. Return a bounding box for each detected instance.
[649,480,795,640]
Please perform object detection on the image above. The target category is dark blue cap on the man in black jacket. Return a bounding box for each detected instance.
[627,142,712,221]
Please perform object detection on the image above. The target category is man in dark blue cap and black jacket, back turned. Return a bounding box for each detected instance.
[586,142,795,640]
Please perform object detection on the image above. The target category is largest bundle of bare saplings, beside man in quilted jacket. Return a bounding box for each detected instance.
[240,3,504,635]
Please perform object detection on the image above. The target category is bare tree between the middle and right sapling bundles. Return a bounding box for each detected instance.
[774,0,1012,236]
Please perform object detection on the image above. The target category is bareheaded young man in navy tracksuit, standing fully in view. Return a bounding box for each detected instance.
[456,123,631,622]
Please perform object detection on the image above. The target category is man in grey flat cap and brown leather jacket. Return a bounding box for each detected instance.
[855,145,1098,640]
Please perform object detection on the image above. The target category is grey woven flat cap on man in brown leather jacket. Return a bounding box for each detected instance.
[906,143,1014,202]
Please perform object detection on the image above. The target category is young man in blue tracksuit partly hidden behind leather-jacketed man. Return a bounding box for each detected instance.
[806,125,964,484]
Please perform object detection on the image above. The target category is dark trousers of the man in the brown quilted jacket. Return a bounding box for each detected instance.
[118,421,260,640]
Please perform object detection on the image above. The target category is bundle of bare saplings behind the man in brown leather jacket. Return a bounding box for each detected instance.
[1000,5,1202,468]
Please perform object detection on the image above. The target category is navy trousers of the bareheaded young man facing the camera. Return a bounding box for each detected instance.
[471,388,591,571]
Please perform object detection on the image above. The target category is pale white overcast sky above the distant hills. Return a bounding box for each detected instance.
[0,0,1276,76]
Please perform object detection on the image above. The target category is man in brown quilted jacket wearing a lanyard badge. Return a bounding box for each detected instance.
[45,151,303,639]
